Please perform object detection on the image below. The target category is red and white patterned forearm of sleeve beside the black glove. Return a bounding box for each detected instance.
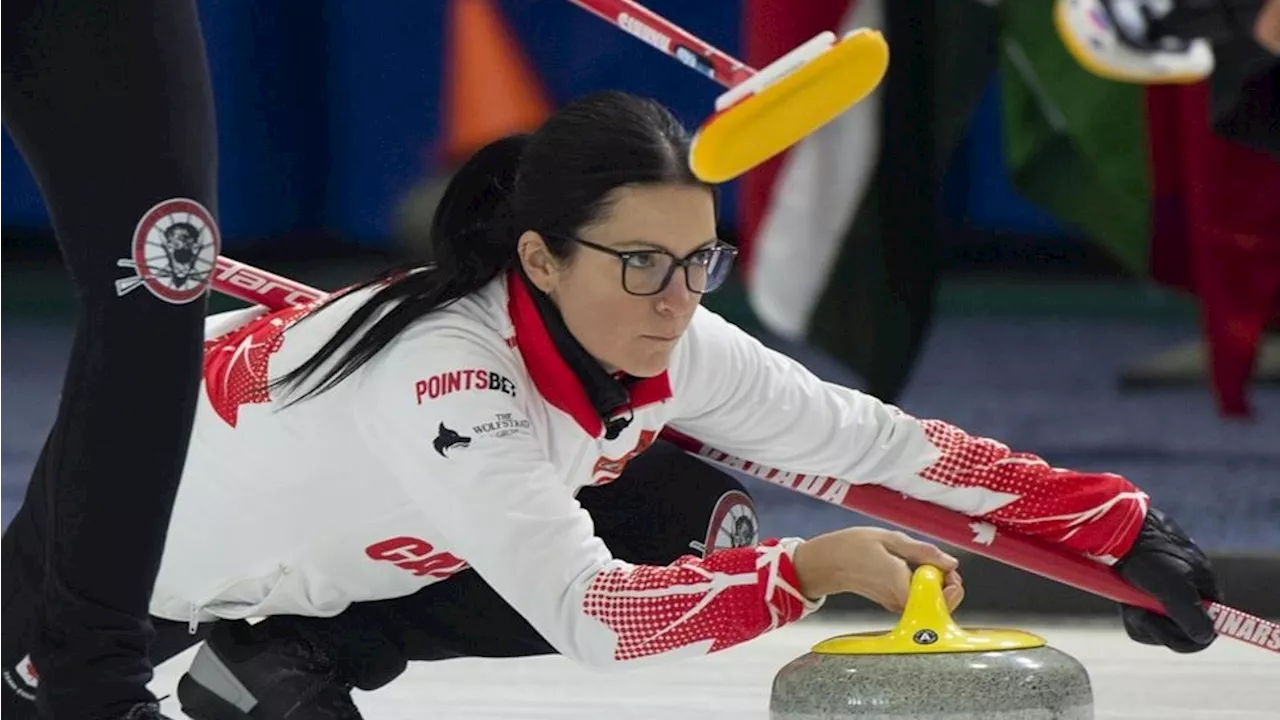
[918,420,1147,564]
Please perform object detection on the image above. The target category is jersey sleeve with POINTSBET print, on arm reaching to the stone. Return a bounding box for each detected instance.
[358,333,817,667]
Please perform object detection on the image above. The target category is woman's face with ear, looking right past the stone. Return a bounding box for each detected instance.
[521,184,716,378]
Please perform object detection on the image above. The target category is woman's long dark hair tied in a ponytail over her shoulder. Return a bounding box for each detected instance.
[275,92,703,400]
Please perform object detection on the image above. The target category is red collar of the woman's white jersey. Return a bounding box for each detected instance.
[507,272,671,437]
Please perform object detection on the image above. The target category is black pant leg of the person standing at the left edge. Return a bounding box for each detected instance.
[0,0,218,720]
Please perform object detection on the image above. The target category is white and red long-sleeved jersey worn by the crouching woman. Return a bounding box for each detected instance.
[152,270,1147,666]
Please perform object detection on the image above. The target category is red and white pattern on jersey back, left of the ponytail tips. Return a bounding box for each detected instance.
[205,305,314,428]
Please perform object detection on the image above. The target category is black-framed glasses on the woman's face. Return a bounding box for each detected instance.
[553,236,737,296]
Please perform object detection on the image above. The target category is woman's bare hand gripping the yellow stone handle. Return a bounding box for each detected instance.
[792,520,964,612]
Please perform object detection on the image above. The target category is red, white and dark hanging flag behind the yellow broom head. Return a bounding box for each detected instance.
[739,0,996,401]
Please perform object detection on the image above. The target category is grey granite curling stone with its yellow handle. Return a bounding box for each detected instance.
[769,566,1093,720]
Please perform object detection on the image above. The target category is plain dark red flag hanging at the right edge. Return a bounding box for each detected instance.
[1147,83,1280,418]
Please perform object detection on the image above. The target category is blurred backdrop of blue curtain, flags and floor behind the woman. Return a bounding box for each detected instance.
[0,0,1280,612]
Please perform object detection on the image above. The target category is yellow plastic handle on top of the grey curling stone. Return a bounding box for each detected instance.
[813,565,1046,655]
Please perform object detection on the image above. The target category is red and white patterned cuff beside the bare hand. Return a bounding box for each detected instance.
[584,539,815,661]
